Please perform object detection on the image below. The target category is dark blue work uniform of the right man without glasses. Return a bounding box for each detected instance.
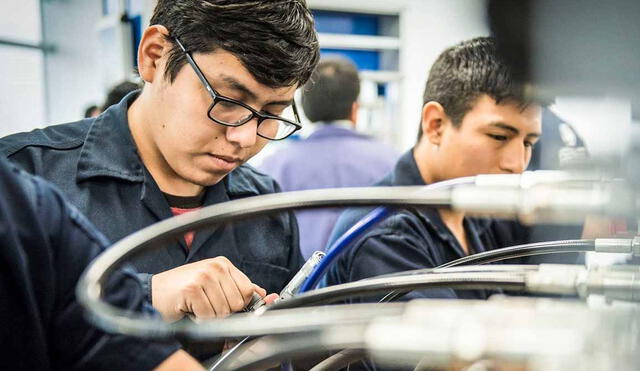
[321,151,528,300]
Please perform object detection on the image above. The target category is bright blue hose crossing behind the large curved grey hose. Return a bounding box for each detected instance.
[298,176,476,293]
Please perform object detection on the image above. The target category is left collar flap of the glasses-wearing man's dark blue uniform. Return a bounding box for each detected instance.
[76,90,144,182]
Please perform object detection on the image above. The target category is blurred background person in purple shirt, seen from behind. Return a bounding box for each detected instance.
[261,57,398,258]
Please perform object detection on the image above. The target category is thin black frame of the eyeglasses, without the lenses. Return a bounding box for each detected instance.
[173,36,302,140]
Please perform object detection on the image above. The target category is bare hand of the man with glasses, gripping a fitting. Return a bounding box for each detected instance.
[151,257,267,322]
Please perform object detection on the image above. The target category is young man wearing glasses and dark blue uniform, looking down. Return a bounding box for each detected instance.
[0,0,319,321]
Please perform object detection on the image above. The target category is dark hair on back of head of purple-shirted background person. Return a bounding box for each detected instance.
[302,57,360,122]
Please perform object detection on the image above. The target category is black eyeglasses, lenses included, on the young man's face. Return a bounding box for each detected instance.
[173,37,302,140]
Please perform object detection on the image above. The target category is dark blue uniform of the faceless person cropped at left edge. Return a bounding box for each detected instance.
[0,159,179,370]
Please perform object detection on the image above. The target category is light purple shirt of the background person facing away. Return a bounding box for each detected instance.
[261,125,399,259]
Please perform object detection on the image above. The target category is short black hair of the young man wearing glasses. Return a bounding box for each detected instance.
[150,0,320,88]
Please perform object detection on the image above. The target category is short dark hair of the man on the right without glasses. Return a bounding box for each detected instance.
[418,37,530,139]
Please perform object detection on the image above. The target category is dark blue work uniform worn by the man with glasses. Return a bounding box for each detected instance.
[0,92,302,297]
